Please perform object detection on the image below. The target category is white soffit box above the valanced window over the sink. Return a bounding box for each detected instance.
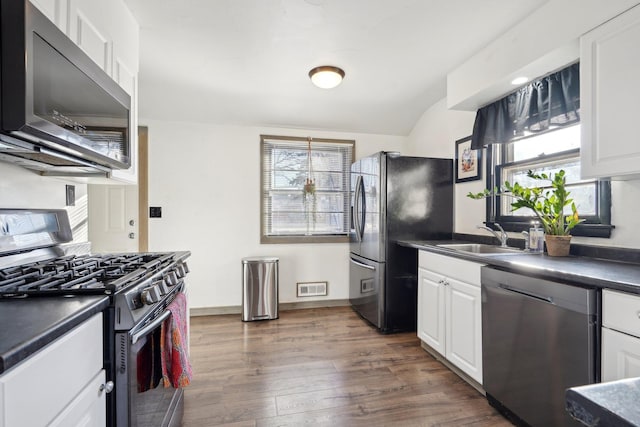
[447,0,638,111]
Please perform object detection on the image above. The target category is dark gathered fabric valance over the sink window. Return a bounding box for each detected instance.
[471,63,580,149]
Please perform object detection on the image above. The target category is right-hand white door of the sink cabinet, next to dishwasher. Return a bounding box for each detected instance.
[445,278,482,384]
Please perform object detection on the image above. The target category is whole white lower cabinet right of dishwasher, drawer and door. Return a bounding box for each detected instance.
[601,289,640,382]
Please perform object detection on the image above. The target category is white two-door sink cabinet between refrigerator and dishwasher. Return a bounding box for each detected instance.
[418,251,482,384]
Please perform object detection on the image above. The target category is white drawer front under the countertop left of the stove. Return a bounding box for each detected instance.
[0,313,103,427]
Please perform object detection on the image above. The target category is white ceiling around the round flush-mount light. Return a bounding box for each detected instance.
[125,0,547,135]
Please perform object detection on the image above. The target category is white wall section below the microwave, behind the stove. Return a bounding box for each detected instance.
[0,162,88,242]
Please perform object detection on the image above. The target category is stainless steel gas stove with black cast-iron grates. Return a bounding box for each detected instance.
[0,209,190,427]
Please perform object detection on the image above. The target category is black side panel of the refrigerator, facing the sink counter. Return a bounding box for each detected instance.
[384,155,453,332]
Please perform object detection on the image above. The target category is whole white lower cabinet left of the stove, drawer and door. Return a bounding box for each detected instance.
[0,314,106,427]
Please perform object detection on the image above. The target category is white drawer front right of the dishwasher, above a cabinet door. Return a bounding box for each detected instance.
[602,289,640,337]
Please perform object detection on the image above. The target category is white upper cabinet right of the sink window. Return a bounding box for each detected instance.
[580,6,640,179]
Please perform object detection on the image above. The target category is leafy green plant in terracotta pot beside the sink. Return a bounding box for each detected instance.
[467,170,584,256]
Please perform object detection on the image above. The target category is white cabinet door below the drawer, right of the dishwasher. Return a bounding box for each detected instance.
[602,328,640,382]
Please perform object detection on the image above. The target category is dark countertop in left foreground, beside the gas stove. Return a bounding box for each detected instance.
[0,295,109,374]
